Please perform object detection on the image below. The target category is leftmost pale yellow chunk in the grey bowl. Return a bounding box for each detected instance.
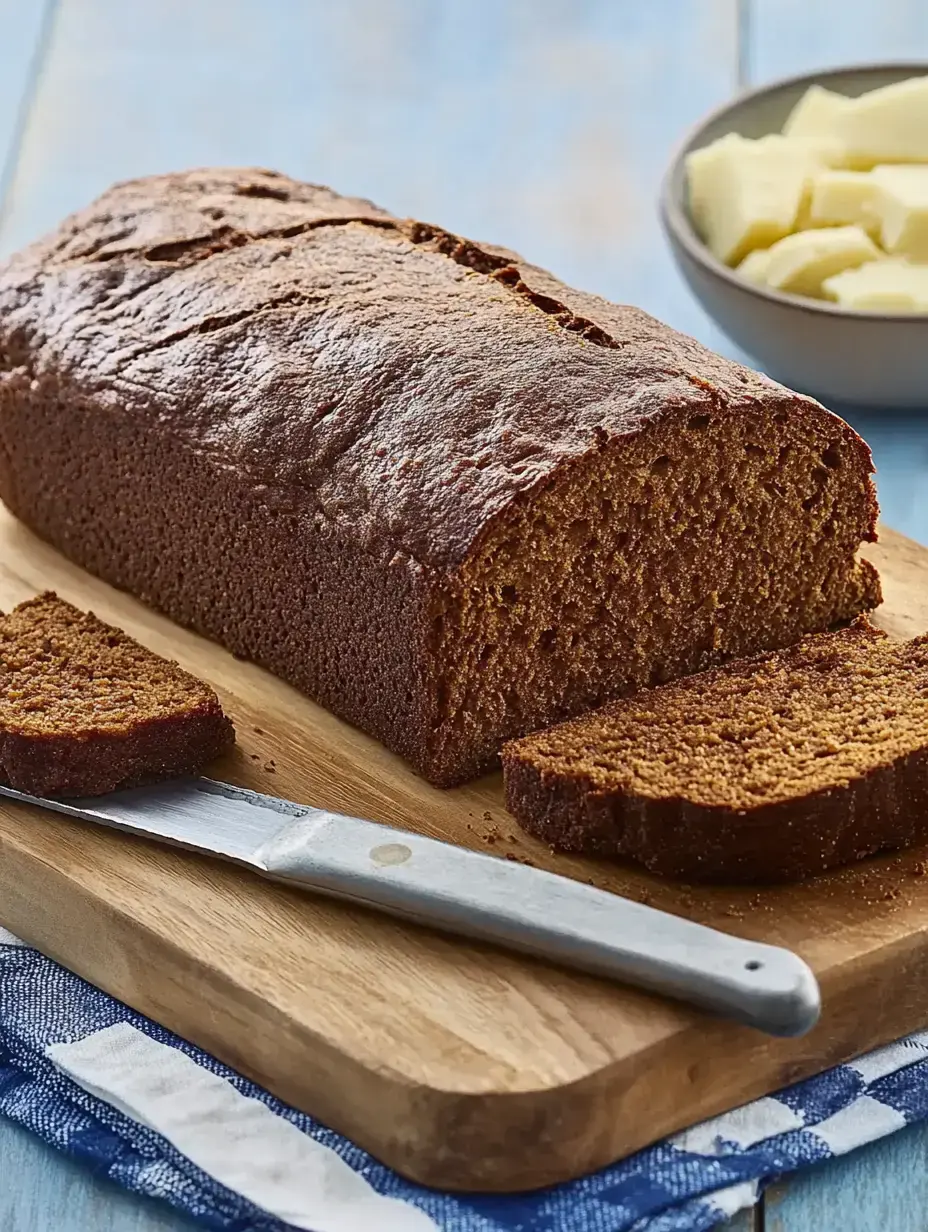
[694,133,821,265]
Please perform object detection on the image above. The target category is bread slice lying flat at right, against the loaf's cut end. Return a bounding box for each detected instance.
[503,617,928,882]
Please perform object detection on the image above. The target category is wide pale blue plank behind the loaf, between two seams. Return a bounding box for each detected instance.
[0,0,737,341]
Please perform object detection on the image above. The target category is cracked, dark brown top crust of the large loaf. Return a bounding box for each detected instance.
[0,169,849,568]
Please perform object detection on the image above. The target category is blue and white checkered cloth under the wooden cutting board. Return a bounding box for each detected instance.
[0,930,928,1232]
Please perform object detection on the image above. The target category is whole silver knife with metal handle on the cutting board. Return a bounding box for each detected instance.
[0,779,821,1036]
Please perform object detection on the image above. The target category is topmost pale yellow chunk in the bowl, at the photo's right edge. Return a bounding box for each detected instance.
[833,76,928,170]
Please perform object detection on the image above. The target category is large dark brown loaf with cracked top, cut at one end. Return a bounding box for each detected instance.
[0,170,880,785]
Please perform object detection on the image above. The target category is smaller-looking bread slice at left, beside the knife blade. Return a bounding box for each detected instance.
[0,593,235,796]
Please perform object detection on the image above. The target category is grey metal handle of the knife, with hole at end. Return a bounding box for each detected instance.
[256,811,821,1035]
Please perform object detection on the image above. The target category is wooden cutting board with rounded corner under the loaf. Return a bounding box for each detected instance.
[0,510,928,1190]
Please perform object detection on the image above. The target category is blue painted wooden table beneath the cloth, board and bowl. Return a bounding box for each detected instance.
[0,0,928,1232]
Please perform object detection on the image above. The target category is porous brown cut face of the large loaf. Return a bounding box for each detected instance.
[430,399,881,782]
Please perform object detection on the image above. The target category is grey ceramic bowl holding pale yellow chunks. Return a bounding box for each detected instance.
[661,63,928,408]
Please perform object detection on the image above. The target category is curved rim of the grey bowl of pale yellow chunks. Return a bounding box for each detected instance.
[659,60,928,325]
